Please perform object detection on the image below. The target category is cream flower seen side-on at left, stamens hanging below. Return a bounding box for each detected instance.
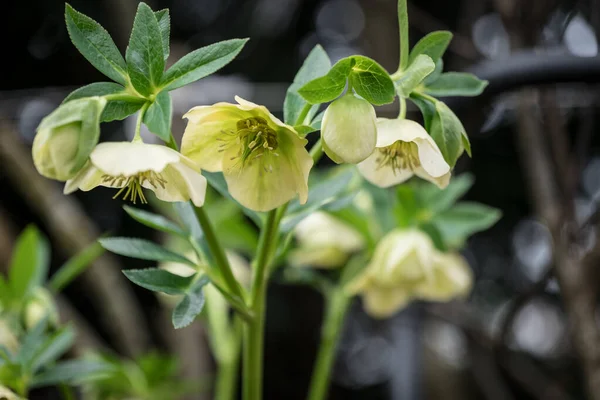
[64,142,206,207]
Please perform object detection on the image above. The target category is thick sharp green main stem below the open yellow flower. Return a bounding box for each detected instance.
[243,210,279,400]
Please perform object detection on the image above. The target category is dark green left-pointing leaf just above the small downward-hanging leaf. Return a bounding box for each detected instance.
[123,268,195,295]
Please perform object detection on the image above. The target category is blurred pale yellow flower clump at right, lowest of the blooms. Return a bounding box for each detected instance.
[347,230,472,318]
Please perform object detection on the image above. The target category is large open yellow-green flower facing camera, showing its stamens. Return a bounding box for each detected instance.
[181,96,313,211]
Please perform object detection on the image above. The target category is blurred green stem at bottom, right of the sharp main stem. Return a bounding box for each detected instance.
[308,288,351,400]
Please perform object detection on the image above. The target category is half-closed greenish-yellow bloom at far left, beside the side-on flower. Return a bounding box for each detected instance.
[32,97,106,181]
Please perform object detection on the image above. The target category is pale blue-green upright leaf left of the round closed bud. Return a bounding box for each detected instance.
[283,45,331,125]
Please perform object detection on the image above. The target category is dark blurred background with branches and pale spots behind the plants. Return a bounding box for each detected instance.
[0,0,600,400]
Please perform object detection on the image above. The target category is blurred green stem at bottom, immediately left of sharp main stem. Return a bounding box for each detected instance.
[214,318,243,400]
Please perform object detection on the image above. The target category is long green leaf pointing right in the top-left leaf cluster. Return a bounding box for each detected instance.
[161,39,248,90]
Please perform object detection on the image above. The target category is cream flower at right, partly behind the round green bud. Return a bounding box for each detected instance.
[358,118,450,189]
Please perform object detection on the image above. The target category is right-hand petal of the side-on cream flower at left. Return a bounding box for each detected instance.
[143,163,206,207]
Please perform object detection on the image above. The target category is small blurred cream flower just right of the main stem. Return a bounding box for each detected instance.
[289,211,365,268]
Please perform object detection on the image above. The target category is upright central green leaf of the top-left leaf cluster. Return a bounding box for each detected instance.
[125,3,165,96]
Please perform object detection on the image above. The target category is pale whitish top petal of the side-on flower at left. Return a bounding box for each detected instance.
[90,142,181,177]
